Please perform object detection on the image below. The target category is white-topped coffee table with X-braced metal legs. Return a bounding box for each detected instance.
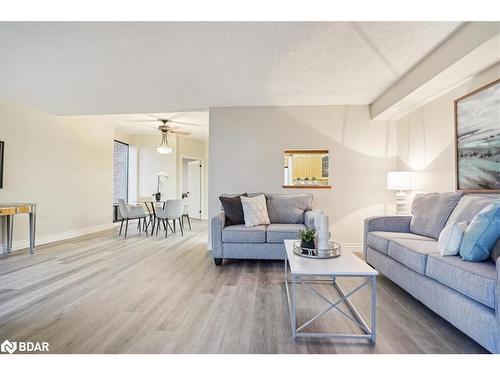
[285,240,378,343]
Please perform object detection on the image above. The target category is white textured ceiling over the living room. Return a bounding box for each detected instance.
[0,22,460,115]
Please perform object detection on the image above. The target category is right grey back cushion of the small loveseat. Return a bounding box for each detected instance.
[267,194,313,224]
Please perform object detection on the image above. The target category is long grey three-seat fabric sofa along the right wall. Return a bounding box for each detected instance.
[364,195,500,353]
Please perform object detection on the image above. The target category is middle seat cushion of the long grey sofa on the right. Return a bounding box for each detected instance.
[387,239,439,275]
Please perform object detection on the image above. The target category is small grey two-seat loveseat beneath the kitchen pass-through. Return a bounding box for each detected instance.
[211,193,315,266]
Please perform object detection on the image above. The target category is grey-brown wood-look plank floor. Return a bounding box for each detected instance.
[0,220,486,353]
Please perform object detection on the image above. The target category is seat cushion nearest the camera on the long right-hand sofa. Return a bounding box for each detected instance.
[426,254,496,309]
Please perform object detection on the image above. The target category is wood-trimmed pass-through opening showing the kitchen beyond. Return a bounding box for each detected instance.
[283,150,331,189]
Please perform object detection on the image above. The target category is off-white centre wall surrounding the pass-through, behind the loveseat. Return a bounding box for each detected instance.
[209,106,397,248]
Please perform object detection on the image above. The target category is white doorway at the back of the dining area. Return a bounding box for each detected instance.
[182,158,203,219]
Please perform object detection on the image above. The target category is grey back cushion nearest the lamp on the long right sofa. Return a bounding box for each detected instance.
[410,192,462,240]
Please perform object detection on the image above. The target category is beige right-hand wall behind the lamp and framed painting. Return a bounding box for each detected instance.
[397,64,500,192]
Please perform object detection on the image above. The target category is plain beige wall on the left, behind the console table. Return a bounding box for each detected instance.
[0,100,113,253]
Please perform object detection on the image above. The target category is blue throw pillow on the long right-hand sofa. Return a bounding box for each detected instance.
[460,200,500,262]
